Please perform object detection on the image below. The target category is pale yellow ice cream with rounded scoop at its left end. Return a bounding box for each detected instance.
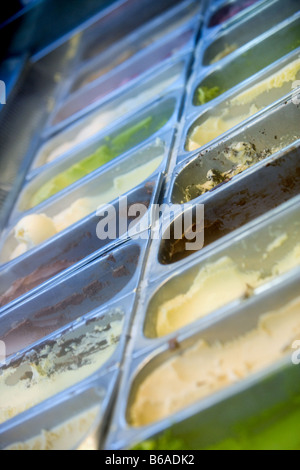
[10,155,164,260]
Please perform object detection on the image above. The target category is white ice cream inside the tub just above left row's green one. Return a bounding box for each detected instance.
[42,74,179,164]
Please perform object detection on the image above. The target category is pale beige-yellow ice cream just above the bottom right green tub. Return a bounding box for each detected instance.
[129,298,300,426]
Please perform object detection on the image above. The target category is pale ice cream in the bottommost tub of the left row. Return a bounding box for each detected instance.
[4,406,100,450]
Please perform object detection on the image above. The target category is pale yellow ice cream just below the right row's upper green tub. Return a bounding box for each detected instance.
[187,59,300,151]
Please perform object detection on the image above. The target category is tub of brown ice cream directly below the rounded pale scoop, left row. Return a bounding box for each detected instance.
[0,163,162,313]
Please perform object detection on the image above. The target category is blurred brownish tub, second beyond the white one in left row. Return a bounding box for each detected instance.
[69,1,200,97]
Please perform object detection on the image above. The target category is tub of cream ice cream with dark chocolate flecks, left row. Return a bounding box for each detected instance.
[0,295,134,436]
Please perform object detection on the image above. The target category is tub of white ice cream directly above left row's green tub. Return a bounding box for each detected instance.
[28,56,190,174]
